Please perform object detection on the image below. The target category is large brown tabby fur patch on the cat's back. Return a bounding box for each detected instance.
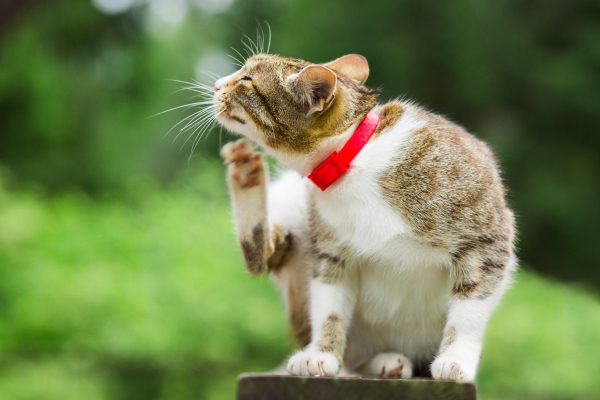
[377,103,513,247]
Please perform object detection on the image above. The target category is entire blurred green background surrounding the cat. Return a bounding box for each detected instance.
[0,0,600,399]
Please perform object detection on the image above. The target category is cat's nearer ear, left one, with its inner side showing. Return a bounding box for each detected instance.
[289,65,337,116]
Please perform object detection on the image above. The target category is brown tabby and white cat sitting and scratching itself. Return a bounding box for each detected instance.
[213,54,517,382]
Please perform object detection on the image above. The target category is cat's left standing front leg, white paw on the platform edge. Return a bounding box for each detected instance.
[287,254,355,376]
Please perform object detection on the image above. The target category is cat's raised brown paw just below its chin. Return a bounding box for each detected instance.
[221,139,266,189]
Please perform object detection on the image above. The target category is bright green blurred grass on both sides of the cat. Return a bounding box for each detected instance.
[0,164,600,400]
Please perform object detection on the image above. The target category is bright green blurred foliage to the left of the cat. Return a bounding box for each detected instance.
[0,165,291,399]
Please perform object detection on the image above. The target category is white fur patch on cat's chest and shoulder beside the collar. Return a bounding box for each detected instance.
[312,106,423,255]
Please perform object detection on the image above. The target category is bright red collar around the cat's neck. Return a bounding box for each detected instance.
[308,110,379,191]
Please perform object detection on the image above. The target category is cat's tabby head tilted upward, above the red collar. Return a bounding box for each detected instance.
[214,54,377,154]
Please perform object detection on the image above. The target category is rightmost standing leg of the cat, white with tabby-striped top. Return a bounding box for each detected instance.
[431,245,516,382]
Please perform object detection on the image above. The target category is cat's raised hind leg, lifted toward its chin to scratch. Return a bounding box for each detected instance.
[221,139,291,274]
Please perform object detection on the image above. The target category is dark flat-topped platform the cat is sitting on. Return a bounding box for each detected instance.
[237,374,477,400]
